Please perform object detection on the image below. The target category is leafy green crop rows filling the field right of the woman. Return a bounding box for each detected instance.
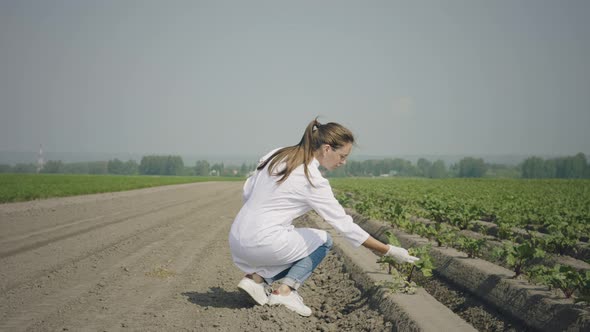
[333,179,590,300]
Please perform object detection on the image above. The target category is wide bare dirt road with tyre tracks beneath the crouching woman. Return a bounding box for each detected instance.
[0,182,391,331]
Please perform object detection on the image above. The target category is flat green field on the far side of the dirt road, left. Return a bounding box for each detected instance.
[0,174,244,203]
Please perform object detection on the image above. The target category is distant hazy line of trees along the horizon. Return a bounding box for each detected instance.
[0,153,590,179]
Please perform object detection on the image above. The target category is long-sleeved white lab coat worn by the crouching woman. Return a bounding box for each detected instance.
[229,150,369,278]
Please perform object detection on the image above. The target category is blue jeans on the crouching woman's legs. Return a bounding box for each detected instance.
[264,234,333,289]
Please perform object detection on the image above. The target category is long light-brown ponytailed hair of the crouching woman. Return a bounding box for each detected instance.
[257,117,354,186]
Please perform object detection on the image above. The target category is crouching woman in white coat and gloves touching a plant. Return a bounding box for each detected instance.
[229,118,418,316]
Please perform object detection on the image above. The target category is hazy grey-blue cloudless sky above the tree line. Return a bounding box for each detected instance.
[0,0,590,156]
